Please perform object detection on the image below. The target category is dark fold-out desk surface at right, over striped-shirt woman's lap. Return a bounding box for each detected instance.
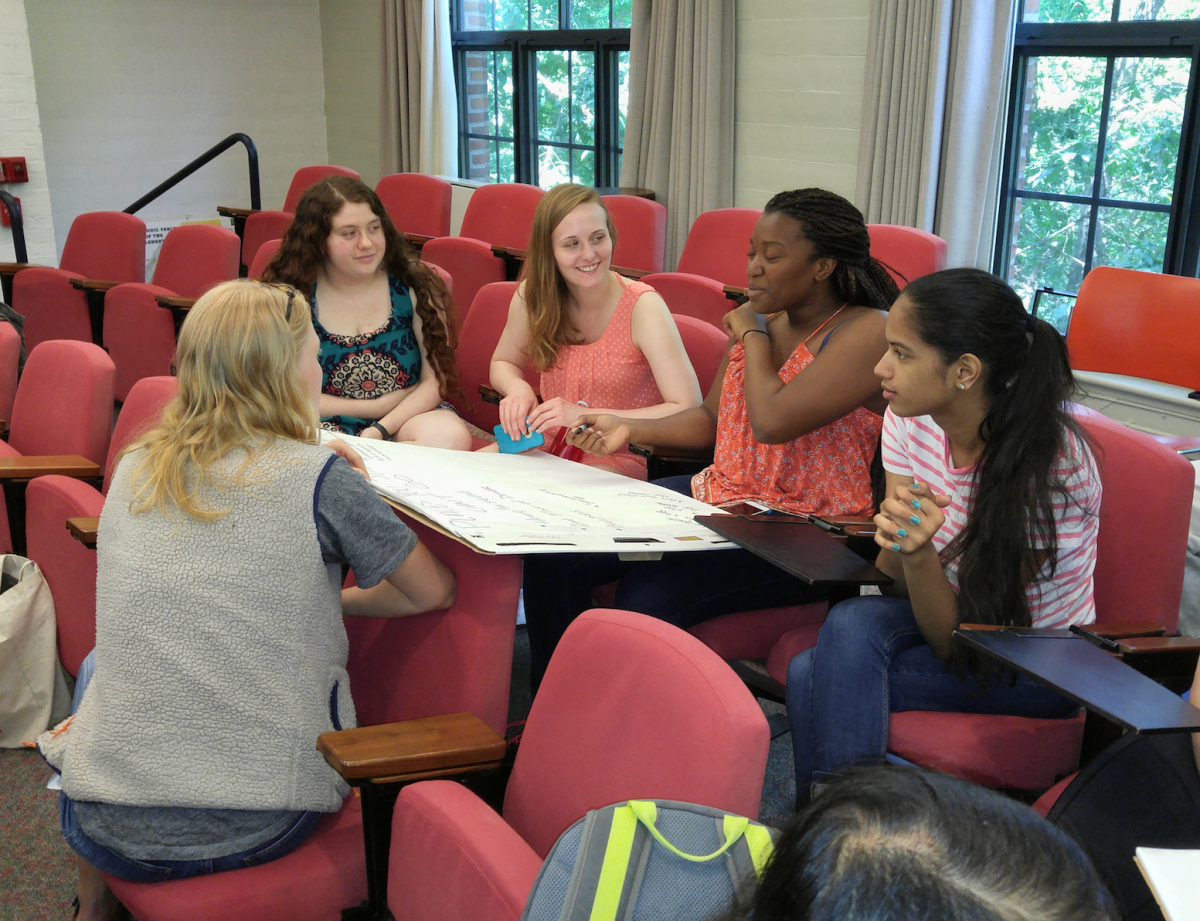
[954,630,1200,733]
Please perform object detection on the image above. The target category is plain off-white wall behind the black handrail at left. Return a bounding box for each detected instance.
[25,0,329,255]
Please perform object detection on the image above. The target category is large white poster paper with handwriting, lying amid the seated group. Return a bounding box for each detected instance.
[326,437,733,553]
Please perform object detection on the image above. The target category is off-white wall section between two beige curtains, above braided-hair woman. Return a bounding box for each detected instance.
[734,0,870,207]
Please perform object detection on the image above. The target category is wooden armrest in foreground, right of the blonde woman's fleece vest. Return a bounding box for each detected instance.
[317,714,508,783]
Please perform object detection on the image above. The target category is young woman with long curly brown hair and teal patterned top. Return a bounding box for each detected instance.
[264,176,470,450]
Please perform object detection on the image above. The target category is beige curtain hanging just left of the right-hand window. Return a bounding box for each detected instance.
[856,0,1015,267]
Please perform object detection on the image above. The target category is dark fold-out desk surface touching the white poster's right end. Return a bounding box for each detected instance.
[696,514,892,585]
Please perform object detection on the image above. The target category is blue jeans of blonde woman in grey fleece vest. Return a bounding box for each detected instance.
[59,649,320,883]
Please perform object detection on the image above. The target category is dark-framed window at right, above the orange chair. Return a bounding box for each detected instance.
[994,0,1200,330]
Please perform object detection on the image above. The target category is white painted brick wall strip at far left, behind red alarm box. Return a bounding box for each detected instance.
[0,0,59,265]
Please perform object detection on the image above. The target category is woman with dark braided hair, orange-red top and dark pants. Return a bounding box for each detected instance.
[524,188,898,686]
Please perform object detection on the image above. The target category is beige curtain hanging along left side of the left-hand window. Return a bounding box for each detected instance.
[380,0,458,176]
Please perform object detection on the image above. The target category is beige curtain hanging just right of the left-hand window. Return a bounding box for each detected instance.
[620,0,737,266]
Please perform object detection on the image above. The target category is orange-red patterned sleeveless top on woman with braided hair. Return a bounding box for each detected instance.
[691,311,883,514]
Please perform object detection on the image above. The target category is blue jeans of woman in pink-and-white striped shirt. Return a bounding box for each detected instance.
[787,595,1078,791]
